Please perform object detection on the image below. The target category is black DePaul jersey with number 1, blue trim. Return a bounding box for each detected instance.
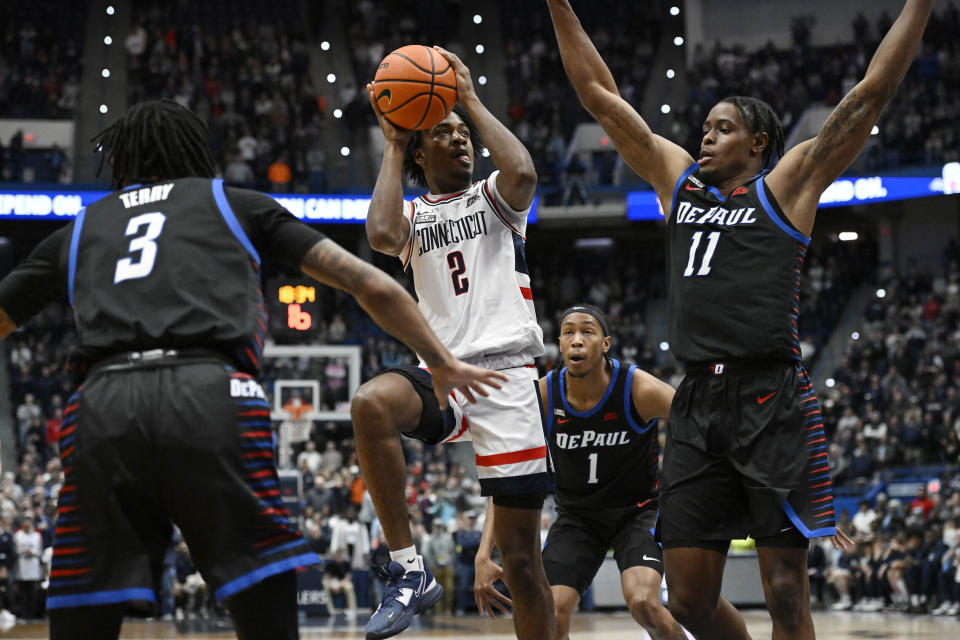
[547,360,660,509]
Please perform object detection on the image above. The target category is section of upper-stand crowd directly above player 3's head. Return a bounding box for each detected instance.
[124,0,326,192]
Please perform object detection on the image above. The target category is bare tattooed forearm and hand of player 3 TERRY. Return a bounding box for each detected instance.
[300,238,506,408]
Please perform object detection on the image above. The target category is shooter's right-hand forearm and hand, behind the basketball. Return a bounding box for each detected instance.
[434,47,537,211]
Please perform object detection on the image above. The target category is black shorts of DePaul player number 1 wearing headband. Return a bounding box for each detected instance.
[543,506,663,597]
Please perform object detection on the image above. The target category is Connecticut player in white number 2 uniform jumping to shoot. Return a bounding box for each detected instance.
[352,49,554,640]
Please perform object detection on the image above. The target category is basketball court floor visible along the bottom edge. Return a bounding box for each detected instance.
[7,609,960,640]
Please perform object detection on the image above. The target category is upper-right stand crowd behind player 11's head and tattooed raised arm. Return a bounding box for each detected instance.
[667,2,960,171]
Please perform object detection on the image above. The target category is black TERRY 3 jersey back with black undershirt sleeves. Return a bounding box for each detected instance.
[0,178,323,373]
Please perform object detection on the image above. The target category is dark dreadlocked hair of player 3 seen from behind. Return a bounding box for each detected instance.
[91,100,217,189]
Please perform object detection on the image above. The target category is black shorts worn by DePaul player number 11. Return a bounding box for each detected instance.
[658,363,835,549]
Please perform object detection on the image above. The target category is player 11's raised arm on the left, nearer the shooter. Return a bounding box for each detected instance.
[547,0,693,205]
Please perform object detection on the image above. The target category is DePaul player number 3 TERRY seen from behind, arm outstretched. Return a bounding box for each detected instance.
[0,101,503,640]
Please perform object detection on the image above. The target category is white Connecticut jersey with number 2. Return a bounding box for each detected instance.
[399,171,543,366]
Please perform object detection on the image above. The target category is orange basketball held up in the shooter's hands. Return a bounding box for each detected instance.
[373,44,457,129]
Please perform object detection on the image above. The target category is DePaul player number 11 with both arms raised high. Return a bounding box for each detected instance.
[547,0,933,640]
